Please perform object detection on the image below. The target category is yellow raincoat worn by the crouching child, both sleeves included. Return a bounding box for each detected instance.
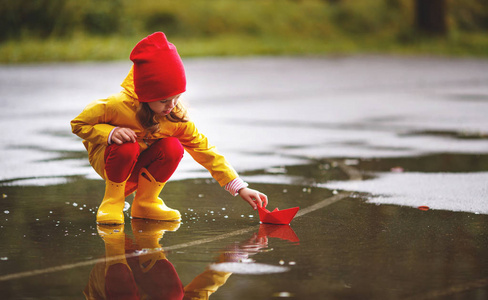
[71,70,238,186]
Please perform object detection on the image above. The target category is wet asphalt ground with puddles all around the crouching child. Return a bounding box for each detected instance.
[0,56,488,299]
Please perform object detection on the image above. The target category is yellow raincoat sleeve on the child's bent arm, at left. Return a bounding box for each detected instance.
[71,100,116,144]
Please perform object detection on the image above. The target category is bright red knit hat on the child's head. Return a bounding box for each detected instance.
[130,32,186,102]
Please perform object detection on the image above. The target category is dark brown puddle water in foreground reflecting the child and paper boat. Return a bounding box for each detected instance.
[0,156,488,299]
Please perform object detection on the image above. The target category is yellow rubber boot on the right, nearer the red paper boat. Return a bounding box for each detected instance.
[131,168,181,221]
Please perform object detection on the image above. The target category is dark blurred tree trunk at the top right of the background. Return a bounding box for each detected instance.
[415,0,448,35]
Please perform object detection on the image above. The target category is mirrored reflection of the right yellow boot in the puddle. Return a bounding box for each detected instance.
[132,219,180,273]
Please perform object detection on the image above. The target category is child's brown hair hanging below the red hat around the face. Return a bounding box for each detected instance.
[136,101,189,134]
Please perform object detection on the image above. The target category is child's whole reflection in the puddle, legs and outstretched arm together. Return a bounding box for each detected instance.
[83,219,268,300]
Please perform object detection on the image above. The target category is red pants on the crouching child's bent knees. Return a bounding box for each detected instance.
[105,137,184,186]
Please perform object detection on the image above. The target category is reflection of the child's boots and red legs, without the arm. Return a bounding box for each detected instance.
[83,219,184,300]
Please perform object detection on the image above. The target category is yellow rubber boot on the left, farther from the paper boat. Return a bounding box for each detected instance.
[97,179,126,225]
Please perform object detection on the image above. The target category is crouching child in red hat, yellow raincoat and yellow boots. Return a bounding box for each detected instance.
[71,32,268,224]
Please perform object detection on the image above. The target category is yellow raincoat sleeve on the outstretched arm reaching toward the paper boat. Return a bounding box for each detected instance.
[176,121,238,186]
